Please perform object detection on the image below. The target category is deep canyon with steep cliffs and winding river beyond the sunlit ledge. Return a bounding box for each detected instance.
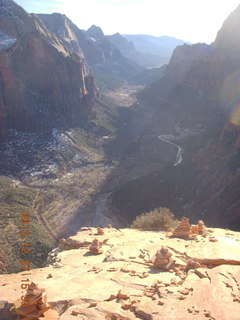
[0,0,240,278]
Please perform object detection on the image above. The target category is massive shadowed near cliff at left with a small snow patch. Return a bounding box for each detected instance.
[0,0,95,134]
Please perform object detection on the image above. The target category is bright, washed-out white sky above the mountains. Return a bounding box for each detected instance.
[15,0,240,43]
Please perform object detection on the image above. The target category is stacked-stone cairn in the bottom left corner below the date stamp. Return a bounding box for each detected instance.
[10,282,58,320]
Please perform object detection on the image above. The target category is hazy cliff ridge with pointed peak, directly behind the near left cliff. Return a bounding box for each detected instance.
[38,13,144,88]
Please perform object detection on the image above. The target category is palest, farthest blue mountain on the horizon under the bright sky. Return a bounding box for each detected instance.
[123,34,190,59]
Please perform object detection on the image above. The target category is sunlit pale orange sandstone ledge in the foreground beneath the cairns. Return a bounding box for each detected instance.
[0,228,240,320]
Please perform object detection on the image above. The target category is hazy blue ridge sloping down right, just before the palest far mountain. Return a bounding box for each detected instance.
[108,33,169,68]
